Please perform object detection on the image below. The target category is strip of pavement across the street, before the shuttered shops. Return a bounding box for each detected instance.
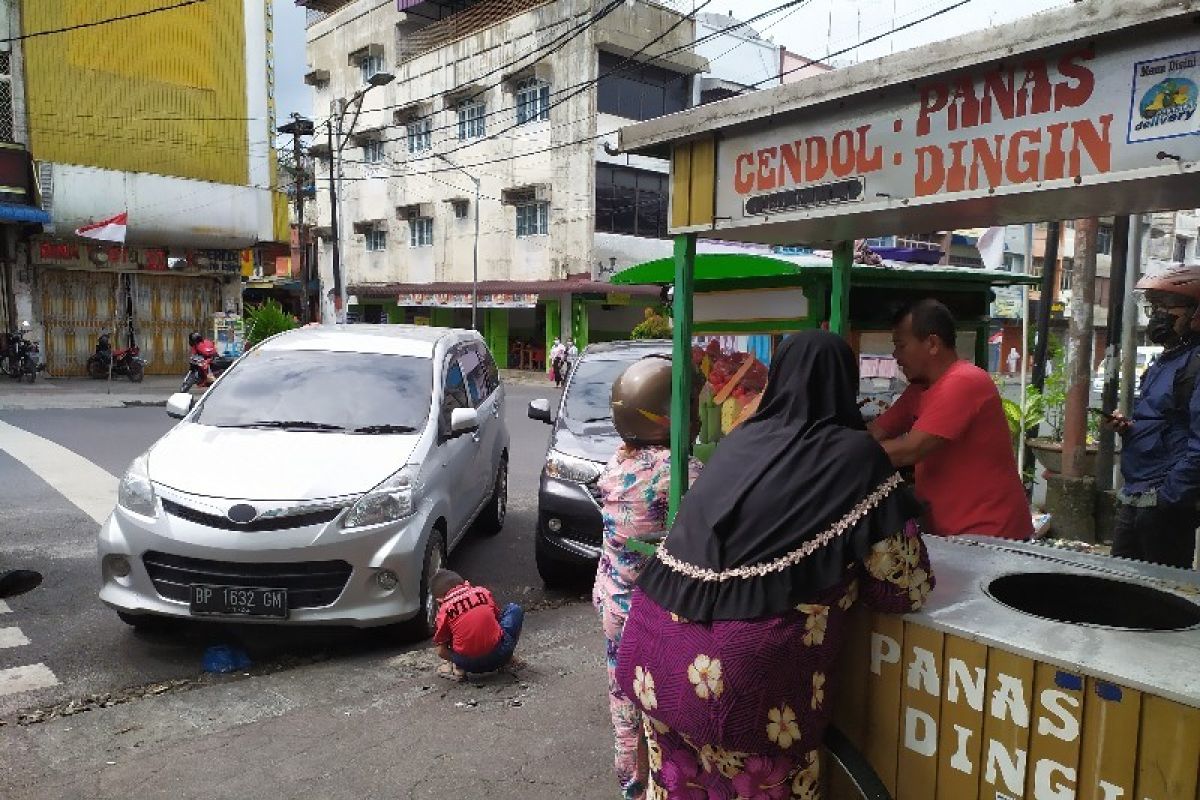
[0,369,554,411]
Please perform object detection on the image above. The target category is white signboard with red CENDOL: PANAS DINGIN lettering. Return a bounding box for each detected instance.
[713,30,1200,241]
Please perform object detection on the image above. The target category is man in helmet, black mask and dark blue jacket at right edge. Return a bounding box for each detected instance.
[1106,264,1200,569]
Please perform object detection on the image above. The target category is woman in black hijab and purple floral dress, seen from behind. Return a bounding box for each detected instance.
[617,331,934,799]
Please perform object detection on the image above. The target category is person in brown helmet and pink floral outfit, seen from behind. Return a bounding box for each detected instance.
[592,356,701,800]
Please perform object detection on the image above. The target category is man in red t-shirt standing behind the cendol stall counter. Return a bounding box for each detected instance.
[868,300,1033,539]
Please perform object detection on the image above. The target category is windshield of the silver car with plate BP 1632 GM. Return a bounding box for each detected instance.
[193,350,433,435]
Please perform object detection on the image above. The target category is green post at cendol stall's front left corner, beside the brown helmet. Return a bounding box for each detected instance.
[667,234,696,528]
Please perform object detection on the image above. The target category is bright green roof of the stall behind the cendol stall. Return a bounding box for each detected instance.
[612,253,1042,287]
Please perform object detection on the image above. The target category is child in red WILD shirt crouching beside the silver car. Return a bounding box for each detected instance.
[430,570,524,678]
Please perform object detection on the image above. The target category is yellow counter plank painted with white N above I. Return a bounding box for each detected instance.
[935,636,988,800]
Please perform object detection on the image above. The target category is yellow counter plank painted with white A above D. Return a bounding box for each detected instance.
[895,622,943,800]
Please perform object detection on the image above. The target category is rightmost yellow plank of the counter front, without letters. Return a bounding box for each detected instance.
[1134,694,1200,800]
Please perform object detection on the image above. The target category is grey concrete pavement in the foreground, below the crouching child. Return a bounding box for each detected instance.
[0,603,619,800]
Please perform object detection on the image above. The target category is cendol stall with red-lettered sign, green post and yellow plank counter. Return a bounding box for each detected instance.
[609,0,1200,800]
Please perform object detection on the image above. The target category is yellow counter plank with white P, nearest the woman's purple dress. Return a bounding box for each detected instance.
[863,614,904,794]
